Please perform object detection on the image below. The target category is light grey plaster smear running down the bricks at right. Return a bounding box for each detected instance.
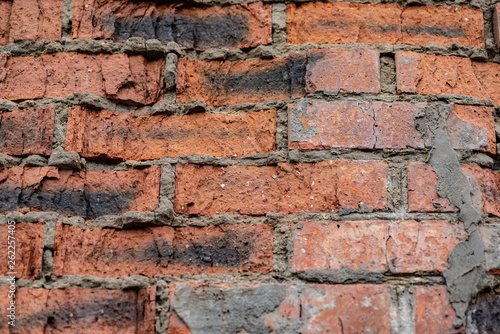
[415,105,489,327]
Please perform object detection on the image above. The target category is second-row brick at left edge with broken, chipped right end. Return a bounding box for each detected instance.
[0,52,165,104]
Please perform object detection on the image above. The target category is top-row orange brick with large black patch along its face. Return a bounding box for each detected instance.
[73,0,272,50]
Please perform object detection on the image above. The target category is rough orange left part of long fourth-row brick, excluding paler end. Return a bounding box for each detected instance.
[174,161,338,215]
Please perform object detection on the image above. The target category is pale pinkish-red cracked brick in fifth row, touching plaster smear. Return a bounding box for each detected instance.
[292,220,467,273]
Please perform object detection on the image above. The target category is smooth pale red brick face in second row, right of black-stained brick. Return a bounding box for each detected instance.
[306,49,380,93]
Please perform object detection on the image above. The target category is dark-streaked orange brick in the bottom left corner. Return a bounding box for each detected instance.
[0,287,156,334]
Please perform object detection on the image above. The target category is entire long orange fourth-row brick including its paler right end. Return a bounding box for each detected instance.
[174,161,387,215]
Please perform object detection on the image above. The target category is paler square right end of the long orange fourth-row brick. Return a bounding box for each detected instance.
[337,160,387,210]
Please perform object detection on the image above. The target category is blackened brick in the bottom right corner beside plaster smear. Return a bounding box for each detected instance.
[465,292,500,334]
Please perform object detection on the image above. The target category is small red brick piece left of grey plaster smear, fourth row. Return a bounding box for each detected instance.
[407,163,458,212]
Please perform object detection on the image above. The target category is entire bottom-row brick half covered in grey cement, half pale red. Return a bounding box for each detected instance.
[168,283,391,334]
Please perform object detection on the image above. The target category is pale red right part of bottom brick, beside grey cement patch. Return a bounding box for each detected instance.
[300,284,391,334]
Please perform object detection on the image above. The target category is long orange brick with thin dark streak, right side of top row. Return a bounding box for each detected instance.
[287,2,485,48]
